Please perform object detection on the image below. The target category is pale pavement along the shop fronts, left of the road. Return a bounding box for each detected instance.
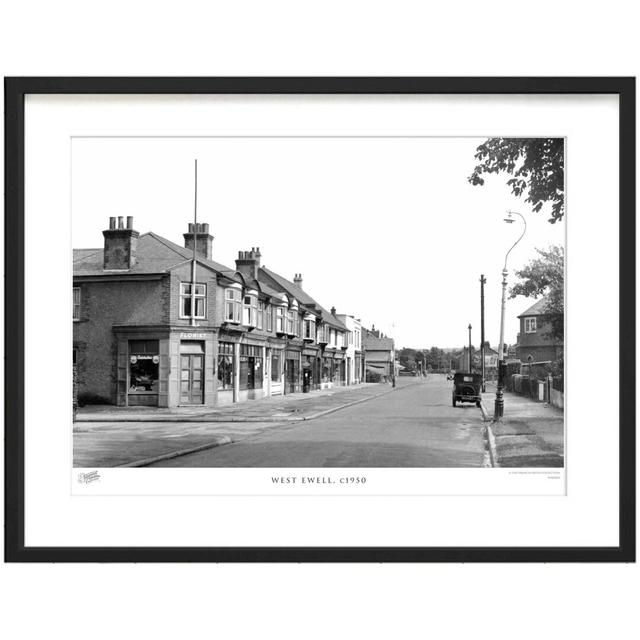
[73,378,423,468]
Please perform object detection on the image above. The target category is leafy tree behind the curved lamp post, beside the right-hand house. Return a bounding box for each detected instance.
[509,245,564,340]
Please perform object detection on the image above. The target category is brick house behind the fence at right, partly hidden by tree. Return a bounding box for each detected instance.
[516,298,564,364]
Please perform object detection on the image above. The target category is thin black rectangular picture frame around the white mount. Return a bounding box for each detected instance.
[4,77,636,562]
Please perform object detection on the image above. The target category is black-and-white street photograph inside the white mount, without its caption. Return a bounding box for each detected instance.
[70,136,566,470]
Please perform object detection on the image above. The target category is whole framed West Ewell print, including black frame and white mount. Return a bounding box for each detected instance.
[5,78,635,562]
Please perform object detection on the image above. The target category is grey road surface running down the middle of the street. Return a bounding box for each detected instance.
[153,375,488,467]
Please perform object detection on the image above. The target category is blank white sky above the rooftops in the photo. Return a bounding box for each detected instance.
[71,137,565,348]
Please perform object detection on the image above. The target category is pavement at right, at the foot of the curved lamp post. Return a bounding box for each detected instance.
[481,384,564,467]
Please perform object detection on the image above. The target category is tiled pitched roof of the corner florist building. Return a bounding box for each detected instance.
[73,231,240,279]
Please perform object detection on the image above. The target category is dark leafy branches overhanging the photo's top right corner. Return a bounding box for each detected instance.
[468,138,564,224]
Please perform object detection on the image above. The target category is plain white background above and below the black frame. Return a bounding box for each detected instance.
[0,1,638,638]
